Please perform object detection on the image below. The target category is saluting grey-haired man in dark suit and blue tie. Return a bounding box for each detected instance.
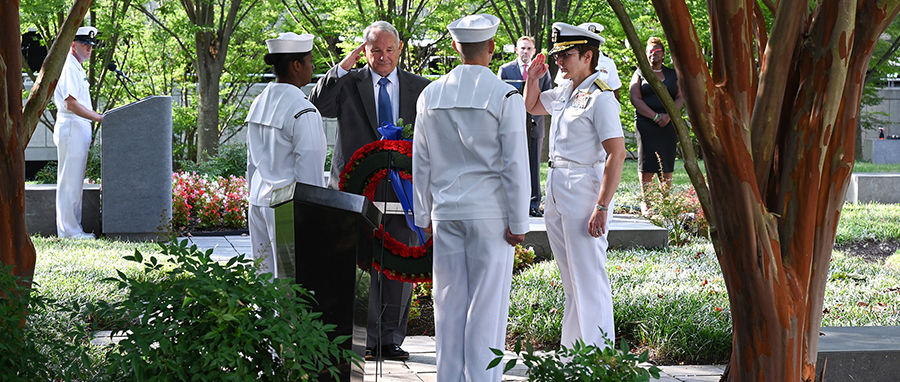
[309,21,430,359]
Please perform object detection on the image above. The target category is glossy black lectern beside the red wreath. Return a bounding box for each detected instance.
[270,183,381,382]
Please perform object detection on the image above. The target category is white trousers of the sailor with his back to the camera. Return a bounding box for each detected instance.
[433,219,514,382]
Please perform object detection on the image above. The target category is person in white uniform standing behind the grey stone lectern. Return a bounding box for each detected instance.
[53,27,103,239]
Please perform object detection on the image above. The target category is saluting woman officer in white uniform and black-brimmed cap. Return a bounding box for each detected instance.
[525,23,625,347]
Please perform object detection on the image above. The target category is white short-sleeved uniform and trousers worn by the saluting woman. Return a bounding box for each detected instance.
[540,72,623,347]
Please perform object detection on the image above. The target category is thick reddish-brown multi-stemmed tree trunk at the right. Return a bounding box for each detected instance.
[610,0,900,381]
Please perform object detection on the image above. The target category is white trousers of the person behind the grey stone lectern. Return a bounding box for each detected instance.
[53,118,91,237]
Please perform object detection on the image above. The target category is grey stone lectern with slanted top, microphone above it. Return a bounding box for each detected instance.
[100,96,172,240]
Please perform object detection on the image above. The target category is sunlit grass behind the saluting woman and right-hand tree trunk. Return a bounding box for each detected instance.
[510,242,900,363]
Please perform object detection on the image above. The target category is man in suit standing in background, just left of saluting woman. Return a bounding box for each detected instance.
[497,36,552,217]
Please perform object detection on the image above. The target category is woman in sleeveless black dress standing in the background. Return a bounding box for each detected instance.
[629,37,684,215]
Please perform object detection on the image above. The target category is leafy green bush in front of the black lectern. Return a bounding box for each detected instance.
[95,240,359,381]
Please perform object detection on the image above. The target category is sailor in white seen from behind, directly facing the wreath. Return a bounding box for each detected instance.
[413,14,540,382]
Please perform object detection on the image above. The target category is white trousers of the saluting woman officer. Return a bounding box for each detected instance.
[544,166,615,348]
